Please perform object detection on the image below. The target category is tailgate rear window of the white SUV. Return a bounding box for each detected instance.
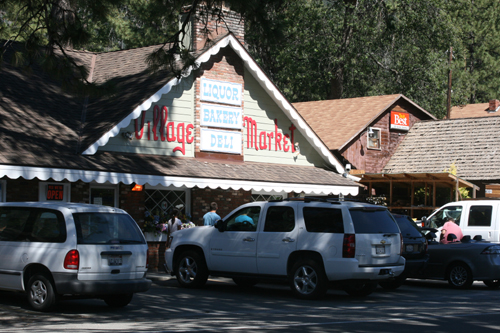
[349,207,400,234]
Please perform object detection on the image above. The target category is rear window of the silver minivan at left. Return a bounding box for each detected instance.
[73,212,145,244]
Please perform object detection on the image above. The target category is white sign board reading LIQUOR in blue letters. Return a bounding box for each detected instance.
[200,78,242,106]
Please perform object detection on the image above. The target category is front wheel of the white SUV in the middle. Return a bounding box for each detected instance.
[175,251,208,288]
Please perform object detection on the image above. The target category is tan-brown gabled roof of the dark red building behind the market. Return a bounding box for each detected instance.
[293,94,436,150]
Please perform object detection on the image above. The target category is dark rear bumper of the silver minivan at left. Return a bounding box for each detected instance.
[53,273,151,295]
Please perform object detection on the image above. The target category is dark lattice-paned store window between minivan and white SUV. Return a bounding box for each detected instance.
[144,185,191,219]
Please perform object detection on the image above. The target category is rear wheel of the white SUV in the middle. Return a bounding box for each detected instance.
[290,259,328,299]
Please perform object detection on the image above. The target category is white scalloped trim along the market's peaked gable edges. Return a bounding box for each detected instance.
[83,35,344,174]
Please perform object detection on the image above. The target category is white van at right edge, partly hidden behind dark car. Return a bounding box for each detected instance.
[422,199,500,242]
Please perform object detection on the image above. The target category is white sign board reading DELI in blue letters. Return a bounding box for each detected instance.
[200,128,241,154]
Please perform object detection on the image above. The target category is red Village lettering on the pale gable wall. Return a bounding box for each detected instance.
[135,105,194,155]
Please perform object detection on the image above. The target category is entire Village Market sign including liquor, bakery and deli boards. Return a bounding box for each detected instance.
[131,78,296,155]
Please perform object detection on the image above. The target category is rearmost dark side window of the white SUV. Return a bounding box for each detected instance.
[303,207,344,234]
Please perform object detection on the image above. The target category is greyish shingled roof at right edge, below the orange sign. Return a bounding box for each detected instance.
[383,117,500,181]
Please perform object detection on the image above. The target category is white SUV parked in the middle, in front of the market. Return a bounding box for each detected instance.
[165,198,405,299]
